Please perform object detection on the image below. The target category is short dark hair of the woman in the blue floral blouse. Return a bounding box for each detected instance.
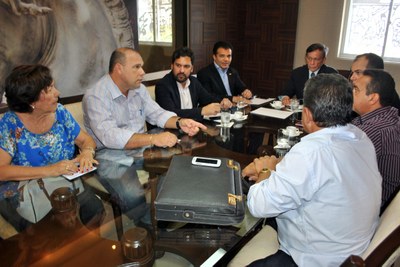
[4,64,53,113]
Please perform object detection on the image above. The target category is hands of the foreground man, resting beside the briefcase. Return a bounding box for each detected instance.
[242,156,281,183]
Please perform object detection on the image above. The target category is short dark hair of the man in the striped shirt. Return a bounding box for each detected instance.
[363,69,397,107]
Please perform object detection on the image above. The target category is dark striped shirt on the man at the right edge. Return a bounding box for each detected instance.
[352,107,400,207]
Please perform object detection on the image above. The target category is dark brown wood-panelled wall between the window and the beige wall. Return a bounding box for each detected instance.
[189,0,299,97]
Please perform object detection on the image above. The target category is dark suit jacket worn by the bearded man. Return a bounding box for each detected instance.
[155,72,219,121]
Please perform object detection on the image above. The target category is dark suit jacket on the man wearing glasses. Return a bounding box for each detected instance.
[281,64,338,99]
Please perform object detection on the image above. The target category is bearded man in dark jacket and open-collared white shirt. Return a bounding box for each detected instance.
[155,47,232,121]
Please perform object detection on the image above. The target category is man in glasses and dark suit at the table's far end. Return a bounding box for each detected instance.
[281,43,338,106]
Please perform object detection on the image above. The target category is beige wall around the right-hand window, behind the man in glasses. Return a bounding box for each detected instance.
[293,0,400,94]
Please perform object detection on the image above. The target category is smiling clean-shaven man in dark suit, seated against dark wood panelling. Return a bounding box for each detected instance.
[197,41,252,103]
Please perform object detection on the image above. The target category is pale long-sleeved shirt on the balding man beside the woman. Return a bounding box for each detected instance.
[82,74,176,149]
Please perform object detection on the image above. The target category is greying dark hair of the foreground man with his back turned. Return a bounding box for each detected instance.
[303,73,353,127]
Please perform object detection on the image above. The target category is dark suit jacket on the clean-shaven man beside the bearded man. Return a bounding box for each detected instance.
[197,62,247,102]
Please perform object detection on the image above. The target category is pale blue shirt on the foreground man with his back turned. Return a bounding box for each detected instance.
[247,124,382,267]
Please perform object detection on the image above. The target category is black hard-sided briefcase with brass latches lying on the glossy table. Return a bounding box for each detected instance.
[155,156,245,225]
